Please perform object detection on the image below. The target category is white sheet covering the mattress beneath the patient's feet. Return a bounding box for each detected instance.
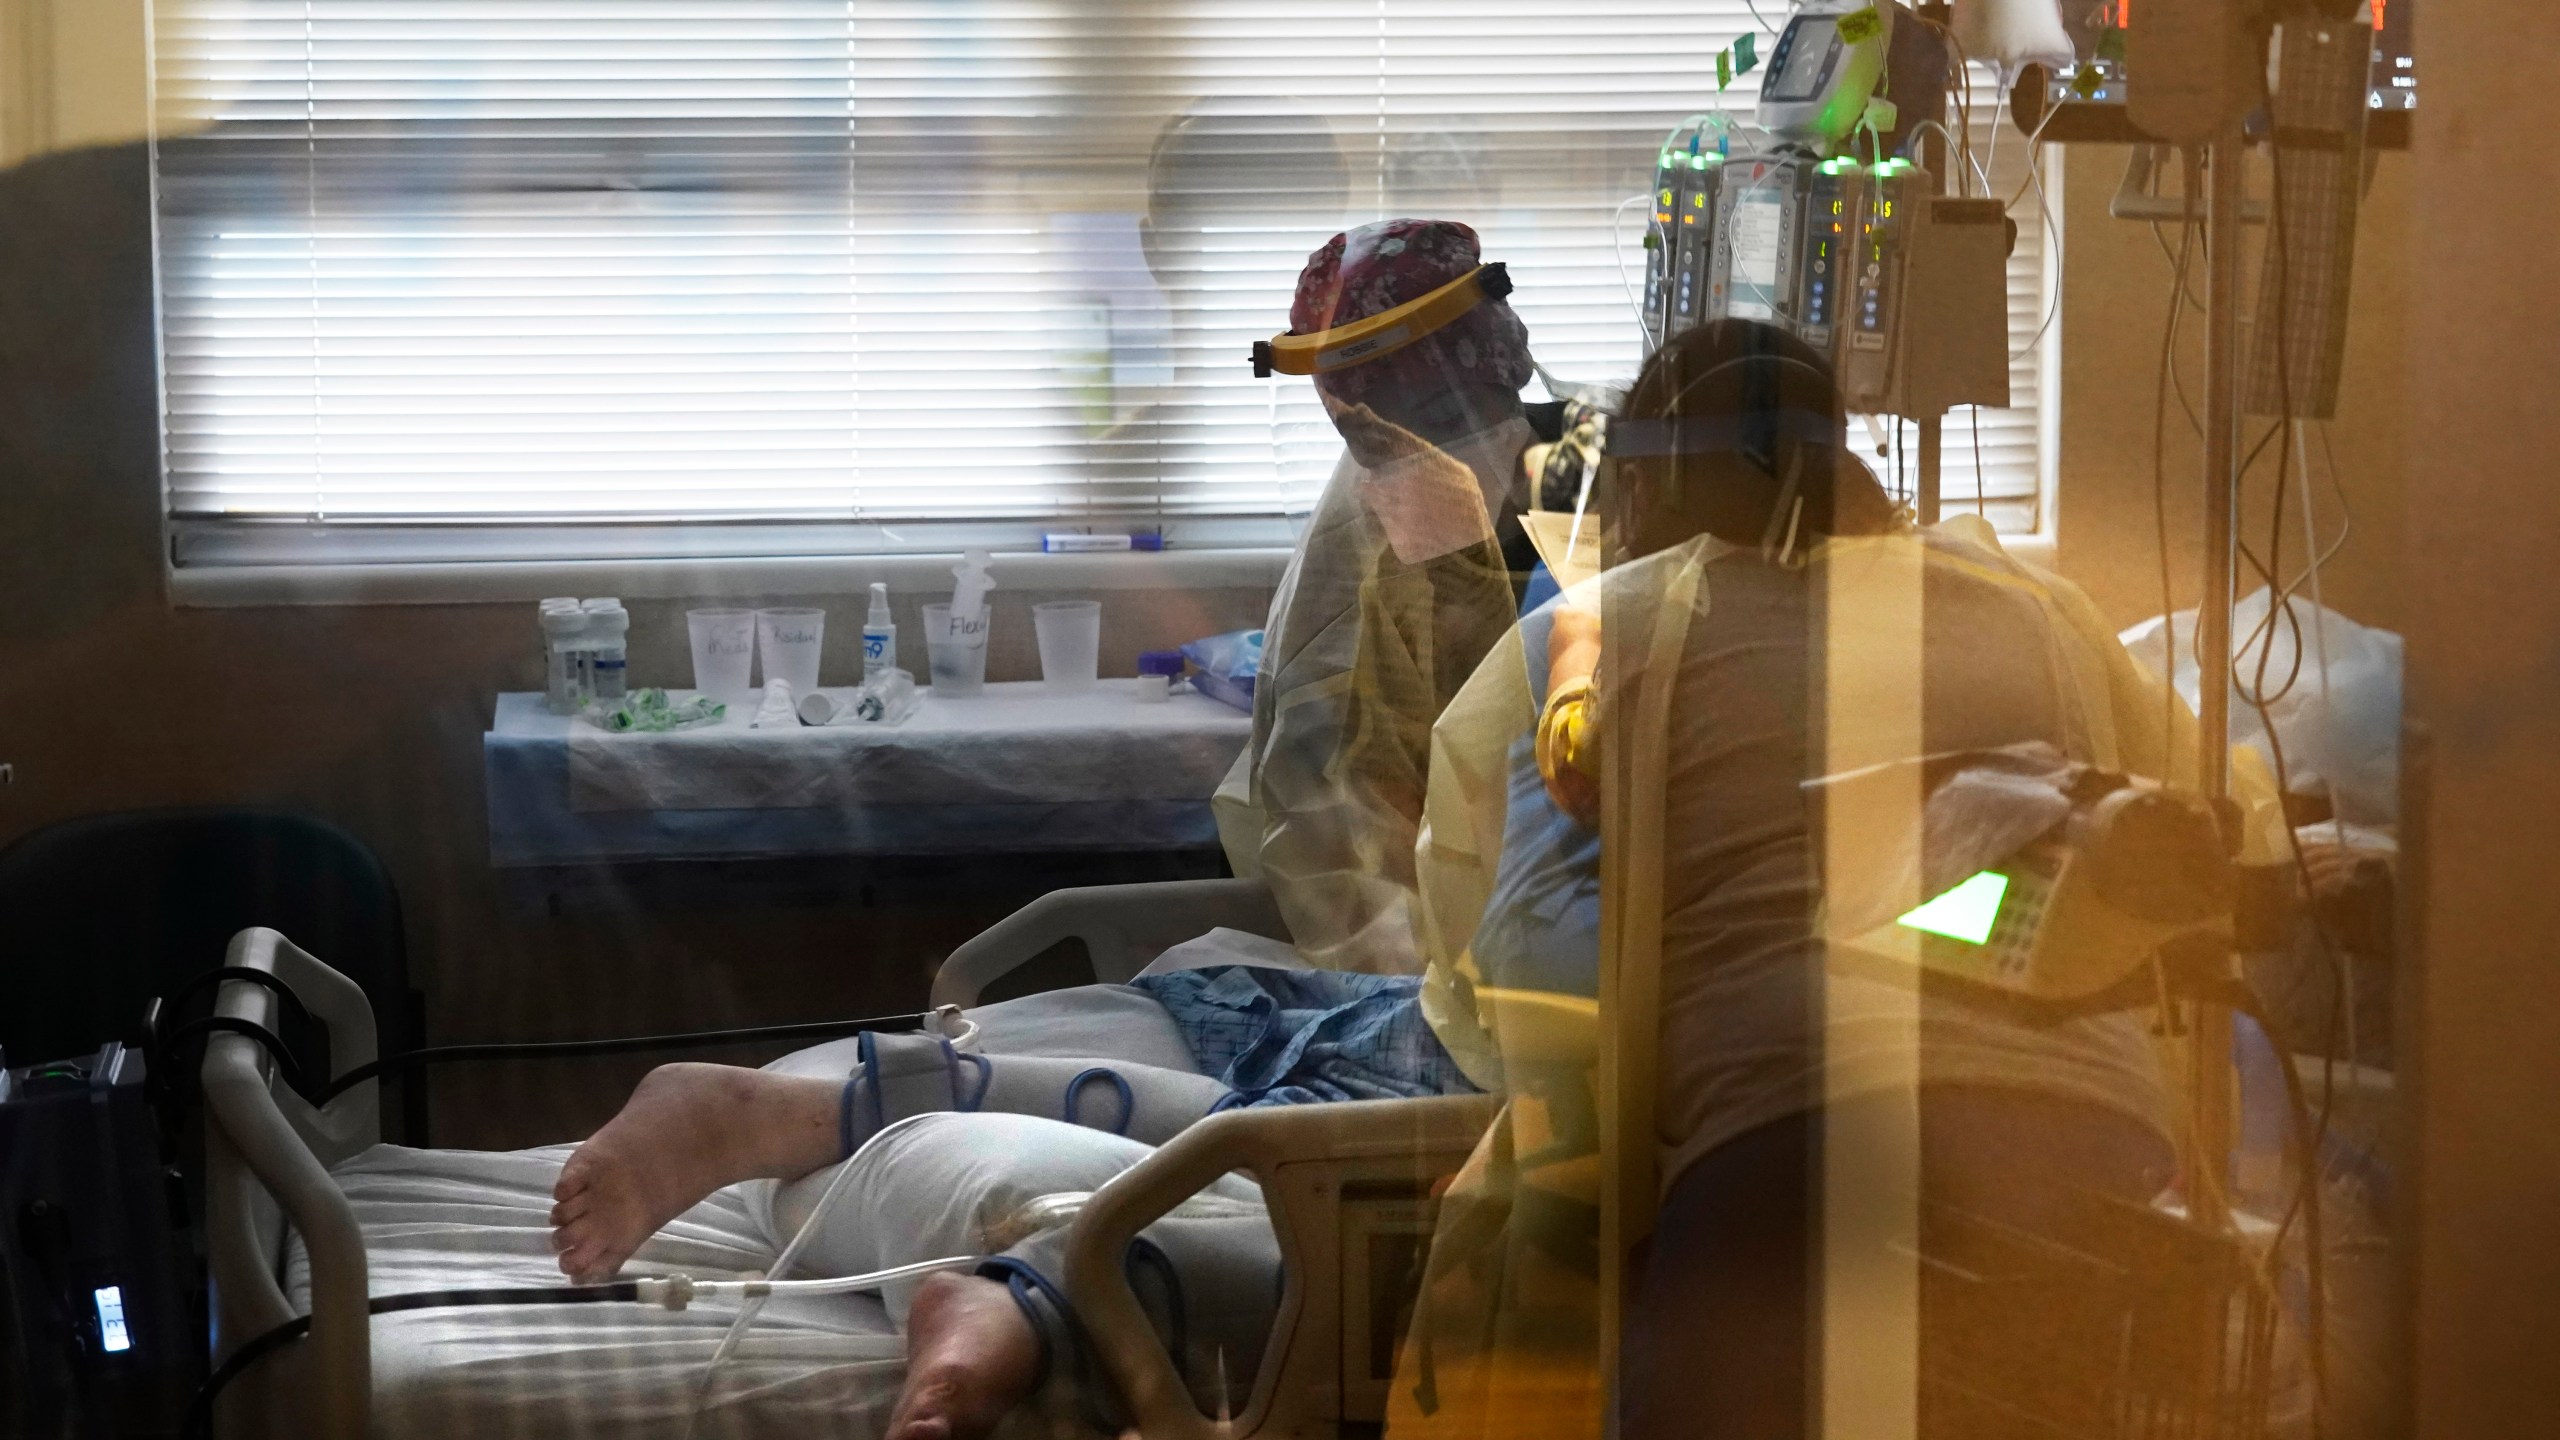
[284,1145,1039,1440]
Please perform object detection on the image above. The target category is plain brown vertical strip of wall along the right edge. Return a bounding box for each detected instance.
[2404,0,2560,1440]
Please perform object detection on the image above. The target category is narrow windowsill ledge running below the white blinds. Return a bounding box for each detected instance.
[169,546,1290,610]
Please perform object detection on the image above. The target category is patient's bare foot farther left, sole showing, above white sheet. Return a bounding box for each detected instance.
[550,1063,840,1284]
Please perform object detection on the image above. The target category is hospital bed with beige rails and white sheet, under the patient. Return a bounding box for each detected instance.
[202,881,1495,1440]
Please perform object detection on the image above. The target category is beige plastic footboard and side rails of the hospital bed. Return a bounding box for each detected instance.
[202,879,1498,1440]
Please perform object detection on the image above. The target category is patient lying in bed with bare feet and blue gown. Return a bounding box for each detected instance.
[550,966,1475,1440]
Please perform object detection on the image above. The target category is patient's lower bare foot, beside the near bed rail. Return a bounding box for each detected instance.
[888,1273,1039,1440]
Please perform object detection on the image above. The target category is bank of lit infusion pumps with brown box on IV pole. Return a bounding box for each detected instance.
[1644,146,2015,418]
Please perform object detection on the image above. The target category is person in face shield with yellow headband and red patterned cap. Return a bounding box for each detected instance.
[1219,220,1554,974]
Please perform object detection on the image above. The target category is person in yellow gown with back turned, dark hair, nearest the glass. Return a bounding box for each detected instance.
[1390,320,2271,1440]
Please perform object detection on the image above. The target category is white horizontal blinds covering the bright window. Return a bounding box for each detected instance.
[156,0,2043,564]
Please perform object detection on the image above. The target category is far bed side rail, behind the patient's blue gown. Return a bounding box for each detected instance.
[932,879,1288,1004]
